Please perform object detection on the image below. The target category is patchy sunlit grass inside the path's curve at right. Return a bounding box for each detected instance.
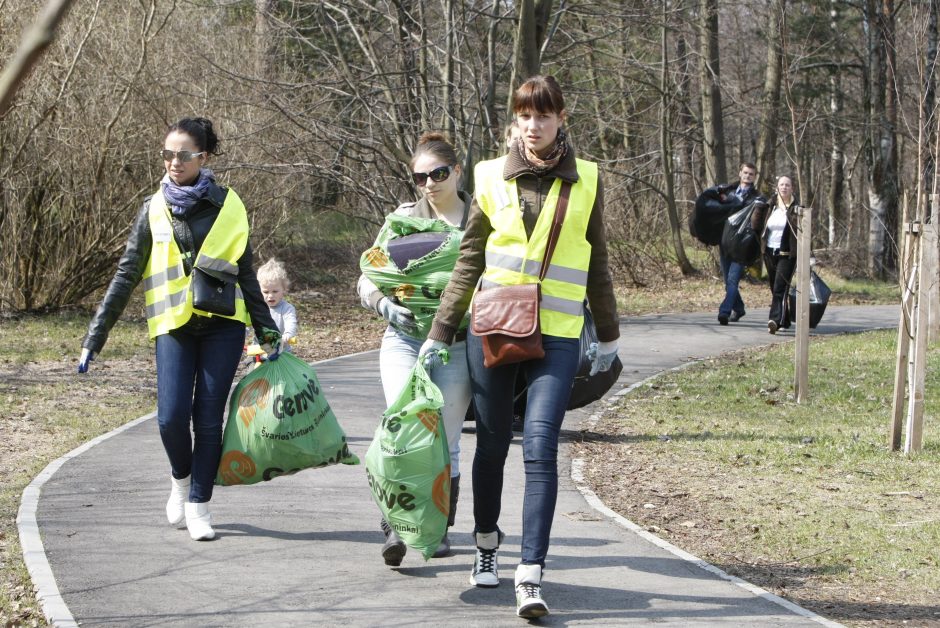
[594,331,940,616]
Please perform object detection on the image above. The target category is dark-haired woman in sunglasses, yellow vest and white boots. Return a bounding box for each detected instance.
[78,118,280,541]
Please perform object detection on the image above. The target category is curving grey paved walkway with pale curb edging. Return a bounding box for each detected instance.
[19,306,897,627]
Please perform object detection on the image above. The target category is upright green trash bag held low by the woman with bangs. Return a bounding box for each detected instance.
[366,361,450,560]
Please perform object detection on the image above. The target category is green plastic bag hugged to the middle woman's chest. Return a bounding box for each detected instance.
[359,214,467,339]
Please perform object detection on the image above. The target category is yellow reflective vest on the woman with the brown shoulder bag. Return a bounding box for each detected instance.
[474,157,597,338]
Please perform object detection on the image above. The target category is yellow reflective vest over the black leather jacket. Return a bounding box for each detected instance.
[144,189,250,338]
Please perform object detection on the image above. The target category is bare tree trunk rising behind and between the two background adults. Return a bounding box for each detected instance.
[754,0,786,193]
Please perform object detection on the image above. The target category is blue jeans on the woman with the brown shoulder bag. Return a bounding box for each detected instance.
[467,333,580,567]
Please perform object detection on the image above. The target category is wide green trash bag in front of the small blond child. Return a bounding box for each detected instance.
[215,353,359,486]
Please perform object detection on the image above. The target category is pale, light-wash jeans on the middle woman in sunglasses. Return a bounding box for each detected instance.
[379,327,470,477]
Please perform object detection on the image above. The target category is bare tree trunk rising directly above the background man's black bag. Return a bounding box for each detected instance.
[699,0,728,185]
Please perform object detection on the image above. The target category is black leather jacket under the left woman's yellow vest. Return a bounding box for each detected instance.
[82,184,277,353]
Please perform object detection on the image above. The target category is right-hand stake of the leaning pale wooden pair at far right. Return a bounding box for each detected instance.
[904,223,937,453]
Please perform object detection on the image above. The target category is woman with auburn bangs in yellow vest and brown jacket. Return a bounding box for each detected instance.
[420,76,620,617]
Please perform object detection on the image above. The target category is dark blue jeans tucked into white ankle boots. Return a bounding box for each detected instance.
[157,317,245,503]
